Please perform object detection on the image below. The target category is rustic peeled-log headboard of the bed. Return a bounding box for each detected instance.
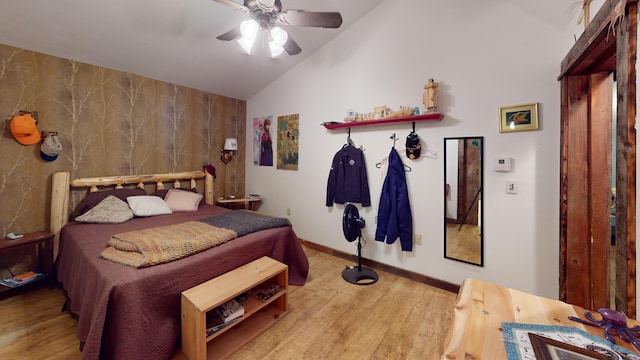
[50,171,213,259]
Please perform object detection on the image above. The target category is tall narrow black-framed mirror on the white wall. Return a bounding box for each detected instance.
[444,136,484,266]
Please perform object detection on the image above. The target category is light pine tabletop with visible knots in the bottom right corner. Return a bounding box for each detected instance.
[442,279,640,360]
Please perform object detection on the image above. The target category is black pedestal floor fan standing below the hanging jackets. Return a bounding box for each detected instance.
[342,204,378,285]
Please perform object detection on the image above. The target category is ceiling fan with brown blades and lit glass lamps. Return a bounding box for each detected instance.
[214,0,342,57]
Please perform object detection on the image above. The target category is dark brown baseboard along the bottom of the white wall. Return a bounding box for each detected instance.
[300,239,460,293]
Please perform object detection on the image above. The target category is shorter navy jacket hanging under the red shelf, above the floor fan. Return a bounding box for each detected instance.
[326,145,371,206]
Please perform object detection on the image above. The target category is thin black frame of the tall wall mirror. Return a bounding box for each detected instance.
[443,136,484,267]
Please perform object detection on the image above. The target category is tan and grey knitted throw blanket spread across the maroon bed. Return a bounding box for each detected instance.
[100,210,290,268]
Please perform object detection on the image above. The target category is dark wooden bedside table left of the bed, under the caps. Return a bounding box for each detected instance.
[0,231,54,298]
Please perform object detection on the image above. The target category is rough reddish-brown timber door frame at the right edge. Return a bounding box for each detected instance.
[558,0,638,318]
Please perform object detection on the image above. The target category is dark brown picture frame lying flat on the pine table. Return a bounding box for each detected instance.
[529,333,612,360]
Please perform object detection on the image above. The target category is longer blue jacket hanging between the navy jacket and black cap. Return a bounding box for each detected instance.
[376,148,413,251]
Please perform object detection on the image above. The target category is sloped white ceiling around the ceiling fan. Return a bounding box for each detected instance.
[0,0,575,100]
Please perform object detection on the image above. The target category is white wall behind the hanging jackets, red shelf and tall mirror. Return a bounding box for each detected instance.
[246,0,573,298]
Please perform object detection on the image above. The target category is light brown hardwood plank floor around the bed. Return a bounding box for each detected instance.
[0,247,456,360]
